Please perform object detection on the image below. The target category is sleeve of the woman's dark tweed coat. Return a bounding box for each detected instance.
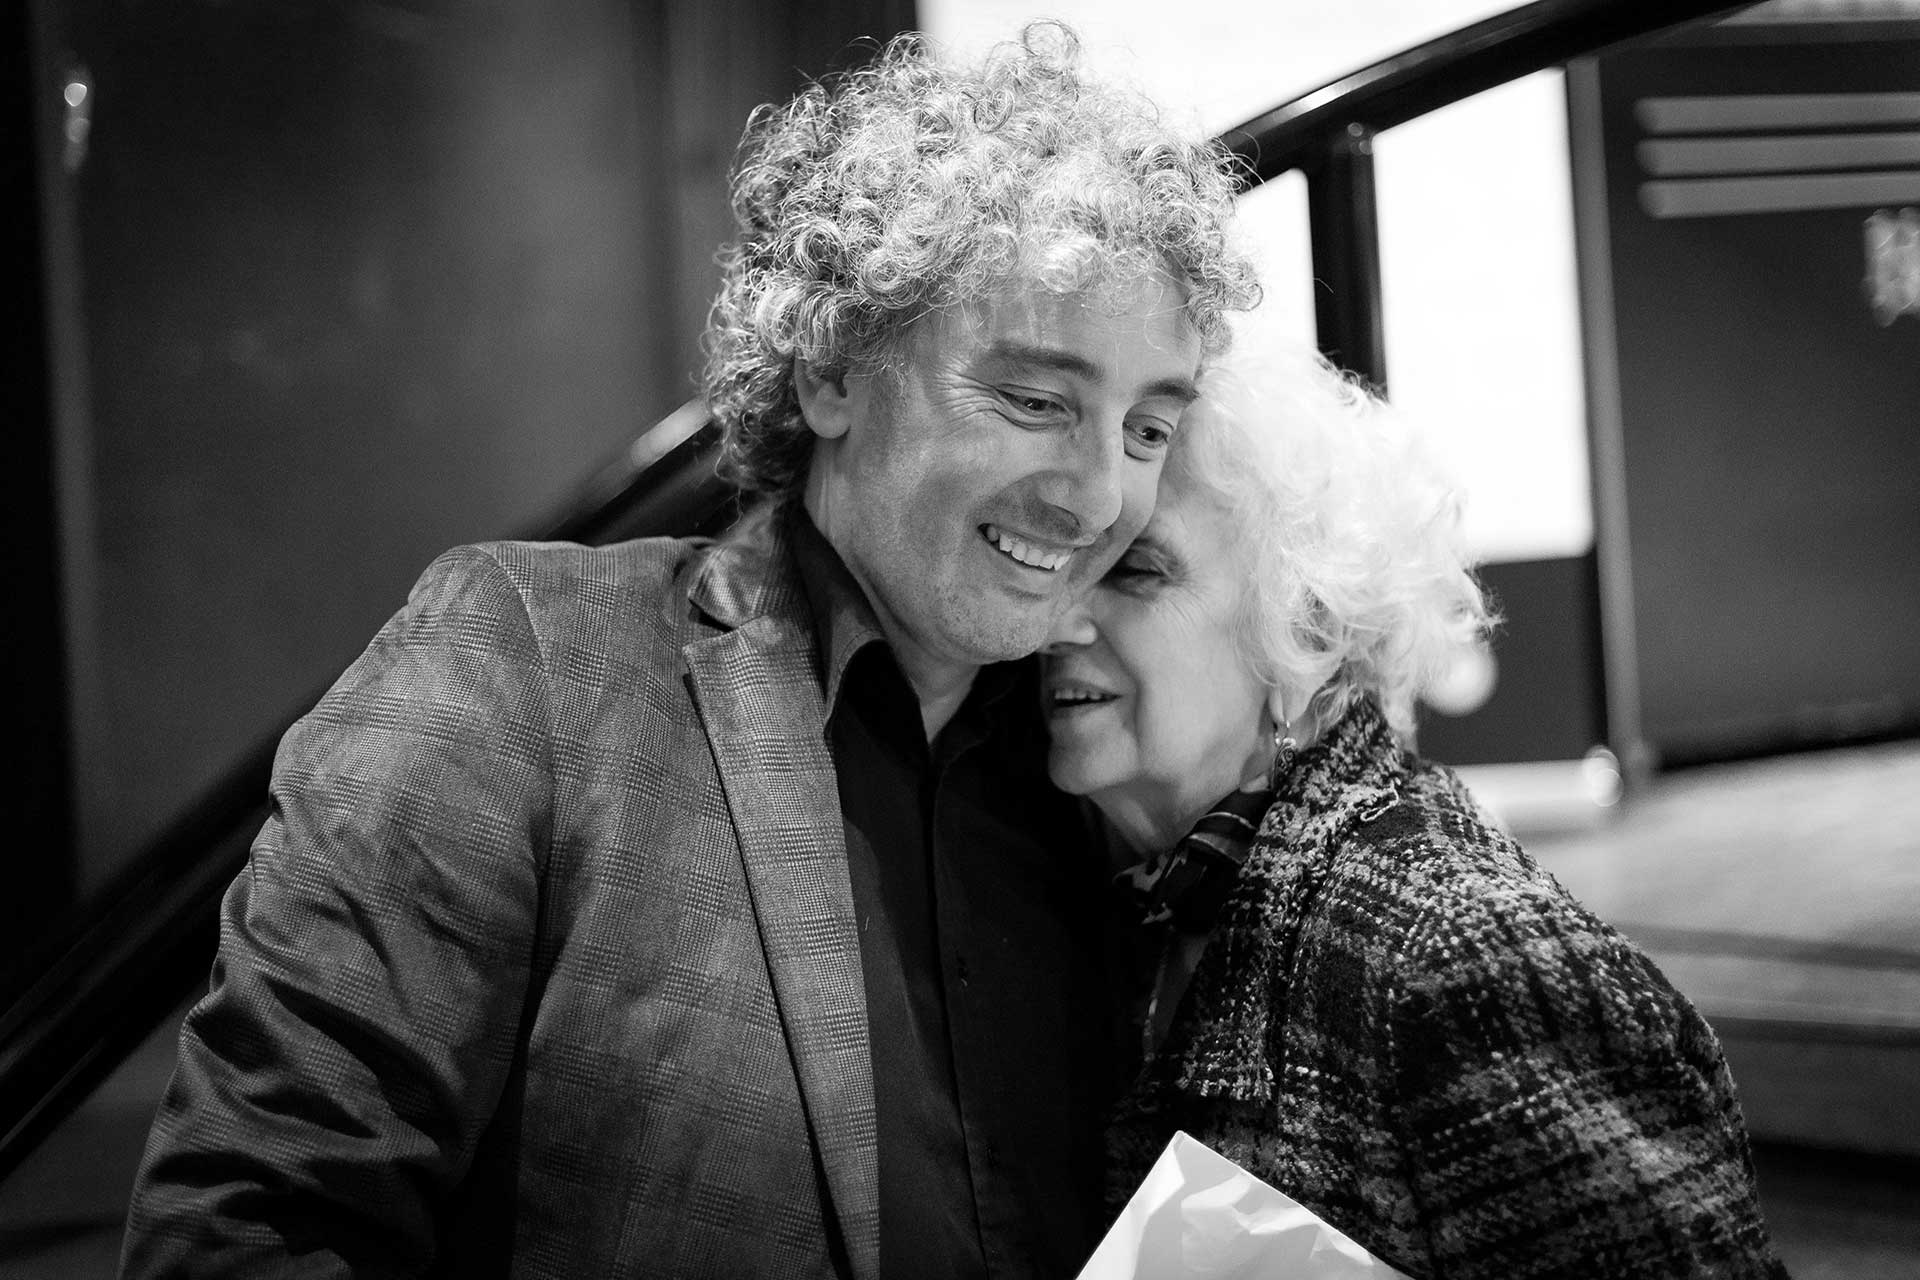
[1392,871,1786,1280]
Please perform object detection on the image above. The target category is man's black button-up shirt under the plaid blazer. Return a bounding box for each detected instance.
[789,505,1112,1280]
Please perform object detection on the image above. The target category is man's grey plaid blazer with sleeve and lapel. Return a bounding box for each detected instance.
[123,506,879,1280]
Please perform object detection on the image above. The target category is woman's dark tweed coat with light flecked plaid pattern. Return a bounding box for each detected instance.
[1110,702,1786,1280]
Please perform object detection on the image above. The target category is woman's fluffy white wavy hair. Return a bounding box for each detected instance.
[1169,345,1496,745]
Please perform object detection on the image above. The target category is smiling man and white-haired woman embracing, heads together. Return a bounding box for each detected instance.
[123,27,1784,1280]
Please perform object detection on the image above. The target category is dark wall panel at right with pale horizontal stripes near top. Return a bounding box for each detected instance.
[1574,21,1920,764]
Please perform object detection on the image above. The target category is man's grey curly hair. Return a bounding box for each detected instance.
[707,23,1260,491]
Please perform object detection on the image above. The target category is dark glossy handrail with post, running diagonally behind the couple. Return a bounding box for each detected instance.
[0,0,1741,1178]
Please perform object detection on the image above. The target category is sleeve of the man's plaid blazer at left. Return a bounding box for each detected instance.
[121,549,551,1276]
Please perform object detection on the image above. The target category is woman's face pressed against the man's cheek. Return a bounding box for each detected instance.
[1043,468,1273,850]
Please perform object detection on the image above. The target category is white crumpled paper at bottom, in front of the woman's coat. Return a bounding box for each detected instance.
[1079,1134,1407,1280]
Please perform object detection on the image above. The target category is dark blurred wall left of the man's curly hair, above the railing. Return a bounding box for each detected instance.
[12,0,910,921]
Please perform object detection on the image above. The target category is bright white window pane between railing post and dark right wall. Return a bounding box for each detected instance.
[1375,71,1594,560]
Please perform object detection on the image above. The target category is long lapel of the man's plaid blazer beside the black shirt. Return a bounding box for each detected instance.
[684,521,879,1280]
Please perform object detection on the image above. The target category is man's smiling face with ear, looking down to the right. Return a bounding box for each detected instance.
[795,278,1200,687]
